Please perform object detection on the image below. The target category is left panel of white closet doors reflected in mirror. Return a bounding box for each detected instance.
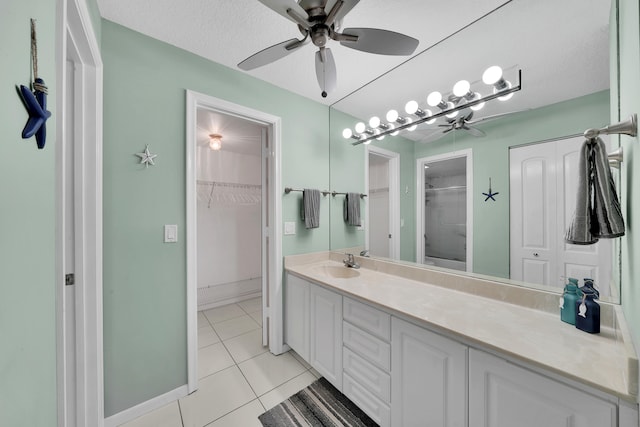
[509,144,558,284]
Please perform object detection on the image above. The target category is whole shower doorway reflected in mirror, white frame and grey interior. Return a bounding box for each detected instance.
[416,150,473,271]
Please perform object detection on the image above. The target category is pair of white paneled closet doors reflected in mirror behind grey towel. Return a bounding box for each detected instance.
[509,137,613,296]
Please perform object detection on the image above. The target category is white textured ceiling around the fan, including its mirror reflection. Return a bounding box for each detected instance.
[98,0,610,145]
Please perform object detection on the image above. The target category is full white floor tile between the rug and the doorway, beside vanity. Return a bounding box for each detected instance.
[238,352,306,396]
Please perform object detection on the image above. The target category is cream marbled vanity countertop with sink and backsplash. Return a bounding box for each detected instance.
[285,252,638,402]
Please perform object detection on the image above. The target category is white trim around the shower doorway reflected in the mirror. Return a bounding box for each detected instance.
[416,148,473,272]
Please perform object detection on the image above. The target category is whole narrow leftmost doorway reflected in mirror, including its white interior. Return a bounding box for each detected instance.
[365,147,400,259]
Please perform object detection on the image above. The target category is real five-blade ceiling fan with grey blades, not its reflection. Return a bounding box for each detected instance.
[238,0,419,97]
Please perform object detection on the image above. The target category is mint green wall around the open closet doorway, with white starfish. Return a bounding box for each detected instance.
[102,21,329,416]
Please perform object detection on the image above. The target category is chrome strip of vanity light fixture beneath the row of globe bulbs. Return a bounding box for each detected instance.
[342,70,522,146]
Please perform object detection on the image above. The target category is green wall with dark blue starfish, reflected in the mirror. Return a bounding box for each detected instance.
[415,91,609,278]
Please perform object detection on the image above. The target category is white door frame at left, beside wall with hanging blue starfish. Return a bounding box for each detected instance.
[55,0,104,427]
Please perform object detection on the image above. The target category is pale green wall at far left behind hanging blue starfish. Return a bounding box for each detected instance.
[0,0,57,427]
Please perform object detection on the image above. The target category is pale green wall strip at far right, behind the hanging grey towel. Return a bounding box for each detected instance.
[619,0,640,362]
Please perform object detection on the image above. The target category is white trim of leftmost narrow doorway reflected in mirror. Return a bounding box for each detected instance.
[364,145,400,260]
